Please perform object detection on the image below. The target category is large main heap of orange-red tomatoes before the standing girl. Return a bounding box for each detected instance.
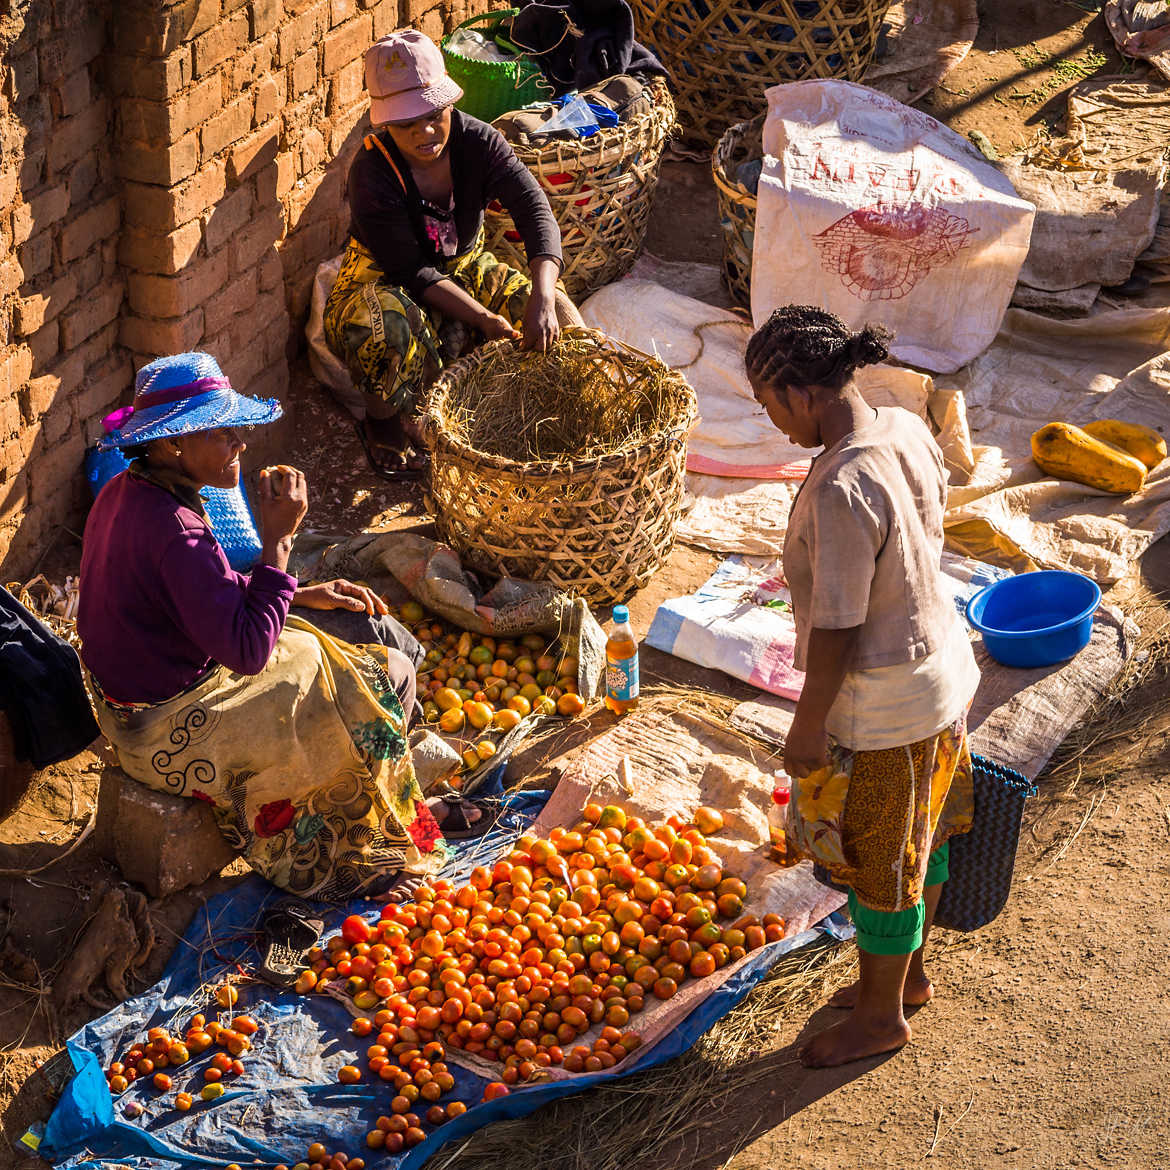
[296,804,784,1090]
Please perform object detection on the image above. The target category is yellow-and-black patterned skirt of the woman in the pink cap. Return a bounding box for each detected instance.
[323,228,532,415]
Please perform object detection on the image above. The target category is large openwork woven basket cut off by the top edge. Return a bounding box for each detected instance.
[631,0,890,146]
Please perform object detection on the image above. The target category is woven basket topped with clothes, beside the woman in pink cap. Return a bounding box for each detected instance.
[484,81,675,300]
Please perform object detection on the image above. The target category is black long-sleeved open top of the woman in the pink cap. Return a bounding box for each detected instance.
[349,110,560,297]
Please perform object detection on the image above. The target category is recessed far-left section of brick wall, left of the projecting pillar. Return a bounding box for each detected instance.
[0,0,132,570]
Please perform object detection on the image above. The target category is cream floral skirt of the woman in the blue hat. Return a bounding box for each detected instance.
[87,617,448,901]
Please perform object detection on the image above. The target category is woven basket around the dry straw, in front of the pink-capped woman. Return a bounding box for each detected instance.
[424,329,697,605]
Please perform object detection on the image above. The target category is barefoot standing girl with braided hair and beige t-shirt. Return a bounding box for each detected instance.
[746,305,979,1067]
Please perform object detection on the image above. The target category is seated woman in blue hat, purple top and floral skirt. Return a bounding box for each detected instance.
[77,353,447,900]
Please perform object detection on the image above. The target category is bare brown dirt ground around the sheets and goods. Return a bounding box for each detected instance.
[0,0,1170,1170]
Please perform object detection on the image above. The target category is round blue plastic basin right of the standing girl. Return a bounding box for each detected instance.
[966,570,1101,667]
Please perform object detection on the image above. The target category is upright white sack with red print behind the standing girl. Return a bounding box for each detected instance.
[751,81,1035,373]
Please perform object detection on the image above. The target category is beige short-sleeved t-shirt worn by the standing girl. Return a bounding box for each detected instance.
[784,407,956,670]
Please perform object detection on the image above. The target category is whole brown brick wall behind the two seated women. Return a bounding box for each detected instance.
[0,0,501,577]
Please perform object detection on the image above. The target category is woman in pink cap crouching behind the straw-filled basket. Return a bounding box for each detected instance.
[324,29,580,480]
